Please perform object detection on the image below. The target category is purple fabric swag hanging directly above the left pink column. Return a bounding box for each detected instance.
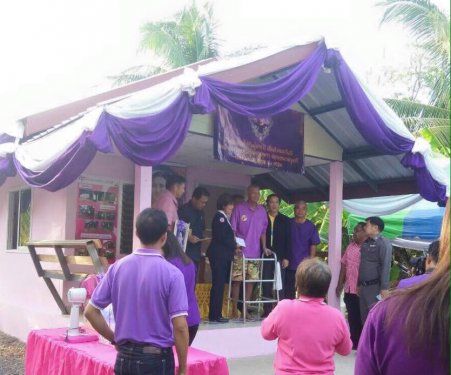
[96,93,192,165]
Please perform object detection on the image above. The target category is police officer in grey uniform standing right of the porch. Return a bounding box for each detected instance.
[358,216,392,324]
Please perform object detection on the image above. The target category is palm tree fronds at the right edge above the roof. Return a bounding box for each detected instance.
[378,0,450,157]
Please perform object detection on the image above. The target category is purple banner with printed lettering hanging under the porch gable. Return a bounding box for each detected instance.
[214,106,304,173]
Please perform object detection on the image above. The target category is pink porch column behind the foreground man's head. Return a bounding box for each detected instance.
[133,165,152,249]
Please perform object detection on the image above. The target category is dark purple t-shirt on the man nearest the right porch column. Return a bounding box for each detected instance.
[288,219,321,271]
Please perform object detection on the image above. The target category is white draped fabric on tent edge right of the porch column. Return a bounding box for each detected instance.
[343,194,423,217]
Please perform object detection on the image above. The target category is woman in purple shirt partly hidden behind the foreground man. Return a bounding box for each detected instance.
[163,232,200,346]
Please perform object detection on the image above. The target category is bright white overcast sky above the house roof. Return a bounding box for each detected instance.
[0,0,449,123]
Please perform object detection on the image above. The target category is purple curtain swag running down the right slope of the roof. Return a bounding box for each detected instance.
[326,49,446,204]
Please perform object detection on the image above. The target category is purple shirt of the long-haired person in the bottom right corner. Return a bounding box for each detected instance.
[354,297,449,375]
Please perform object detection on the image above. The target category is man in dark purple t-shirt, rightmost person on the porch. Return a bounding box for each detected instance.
[285,201,321,299]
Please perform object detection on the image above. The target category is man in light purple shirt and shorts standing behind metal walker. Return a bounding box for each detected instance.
[230,185,271,318]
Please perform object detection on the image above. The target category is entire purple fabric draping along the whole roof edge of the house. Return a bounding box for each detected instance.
[0,42,446,206]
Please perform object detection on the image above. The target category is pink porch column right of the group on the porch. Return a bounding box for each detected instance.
[327,161,343,309]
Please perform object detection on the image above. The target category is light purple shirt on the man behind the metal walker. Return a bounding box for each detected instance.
[230,202,268,258]
